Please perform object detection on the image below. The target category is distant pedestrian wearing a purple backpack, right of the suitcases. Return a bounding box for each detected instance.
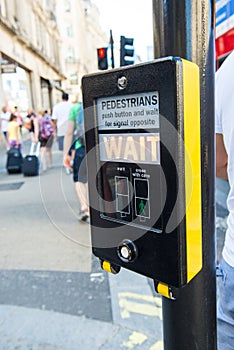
[37,110,54,171]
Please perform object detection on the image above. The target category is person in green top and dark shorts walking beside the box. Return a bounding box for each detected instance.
[63,102,89,222]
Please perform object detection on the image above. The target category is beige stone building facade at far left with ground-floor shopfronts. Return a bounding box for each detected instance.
[0,0,65,112]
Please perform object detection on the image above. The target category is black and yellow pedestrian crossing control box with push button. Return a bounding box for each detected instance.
[82,57,202,297]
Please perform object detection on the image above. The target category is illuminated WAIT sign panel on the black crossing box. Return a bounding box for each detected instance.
[99,133,160,164]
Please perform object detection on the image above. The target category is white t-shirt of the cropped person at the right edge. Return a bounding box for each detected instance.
[215,51,234,267]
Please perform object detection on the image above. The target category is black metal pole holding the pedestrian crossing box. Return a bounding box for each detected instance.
[153,0,217,350]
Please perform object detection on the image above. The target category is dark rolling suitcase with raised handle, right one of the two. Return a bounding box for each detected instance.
[22,142,40,176]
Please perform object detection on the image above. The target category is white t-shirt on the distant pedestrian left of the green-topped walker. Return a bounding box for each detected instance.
[51,101,73,136]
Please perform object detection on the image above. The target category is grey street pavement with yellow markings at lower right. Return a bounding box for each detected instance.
[0,134,228,350]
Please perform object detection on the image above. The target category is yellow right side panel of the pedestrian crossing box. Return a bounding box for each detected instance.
[182,59,202,282]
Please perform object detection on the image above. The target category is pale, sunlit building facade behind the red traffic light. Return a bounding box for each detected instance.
[56,0,108,96]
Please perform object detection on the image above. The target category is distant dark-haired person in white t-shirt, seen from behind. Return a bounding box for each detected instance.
[51,92,73,151]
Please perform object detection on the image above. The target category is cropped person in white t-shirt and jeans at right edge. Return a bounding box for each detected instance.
[215,51,234,350]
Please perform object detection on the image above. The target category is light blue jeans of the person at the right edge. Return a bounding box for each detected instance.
[217,258,234,350]
